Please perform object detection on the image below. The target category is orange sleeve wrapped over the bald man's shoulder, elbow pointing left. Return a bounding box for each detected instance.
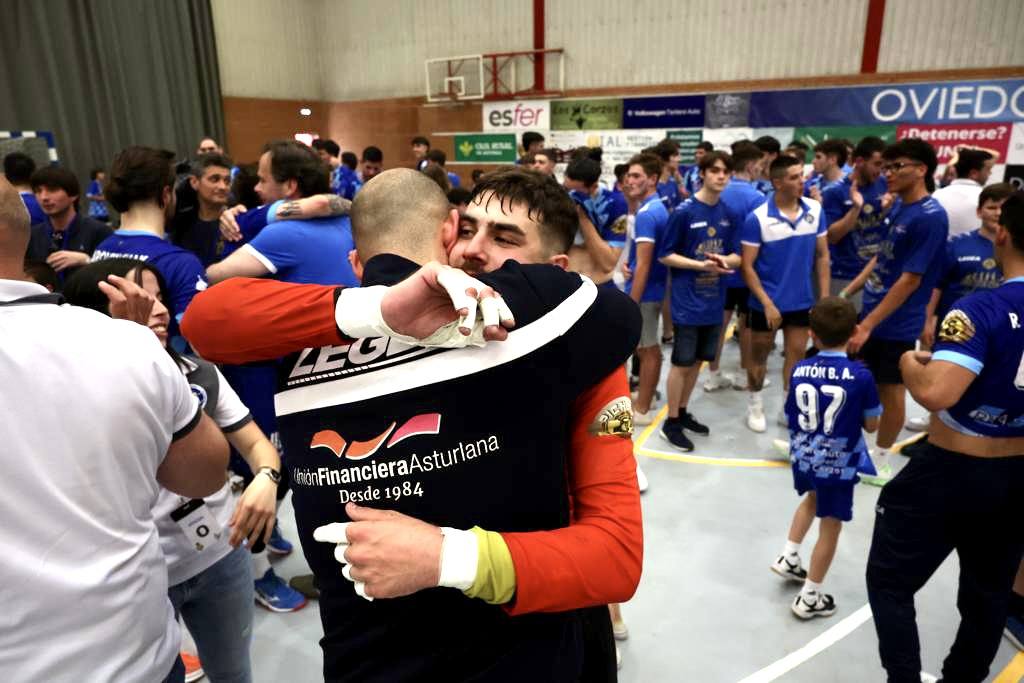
[181,278,344,365]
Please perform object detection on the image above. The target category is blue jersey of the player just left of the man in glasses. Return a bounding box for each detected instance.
[821,176,888,280]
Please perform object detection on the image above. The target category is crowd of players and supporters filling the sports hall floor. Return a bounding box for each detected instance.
[0,124,1024,682]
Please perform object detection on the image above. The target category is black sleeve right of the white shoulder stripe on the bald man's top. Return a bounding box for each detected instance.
[564,287,641,391]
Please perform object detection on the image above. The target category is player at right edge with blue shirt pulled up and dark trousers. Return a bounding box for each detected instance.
[867,191,1024,681]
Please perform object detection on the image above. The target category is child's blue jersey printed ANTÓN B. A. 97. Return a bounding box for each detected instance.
[785,351,882,481]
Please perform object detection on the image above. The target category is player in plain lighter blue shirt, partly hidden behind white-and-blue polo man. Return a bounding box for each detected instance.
[705,140,765,391]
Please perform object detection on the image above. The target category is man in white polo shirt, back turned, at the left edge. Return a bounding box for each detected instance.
[0,180,227,681]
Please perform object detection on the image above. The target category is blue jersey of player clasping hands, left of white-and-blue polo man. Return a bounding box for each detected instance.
[657,197,739,325]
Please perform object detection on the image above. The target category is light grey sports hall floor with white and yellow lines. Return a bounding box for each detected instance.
[252,342,1024,683]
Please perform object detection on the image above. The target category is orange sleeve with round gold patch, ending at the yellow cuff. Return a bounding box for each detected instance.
[502,368,643,615]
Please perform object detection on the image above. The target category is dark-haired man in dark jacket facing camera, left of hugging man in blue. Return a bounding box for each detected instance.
[171,153,233,267]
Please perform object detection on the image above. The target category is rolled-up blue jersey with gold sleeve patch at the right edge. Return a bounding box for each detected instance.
[932,278,1024,437]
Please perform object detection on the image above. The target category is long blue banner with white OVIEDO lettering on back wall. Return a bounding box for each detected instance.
[749,79,1024,128]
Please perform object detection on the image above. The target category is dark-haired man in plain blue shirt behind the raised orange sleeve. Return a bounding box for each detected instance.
[207,140,358,286]
